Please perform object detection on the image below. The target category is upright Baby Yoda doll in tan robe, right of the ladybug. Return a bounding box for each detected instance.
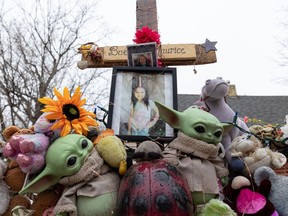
[155,101,230,213]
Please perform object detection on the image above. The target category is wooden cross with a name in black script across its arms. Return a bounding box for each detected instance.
[77,0,217,69]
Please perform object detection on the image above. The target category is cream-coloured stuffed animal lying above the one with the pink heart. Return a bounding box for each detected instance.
[230,134,287,175]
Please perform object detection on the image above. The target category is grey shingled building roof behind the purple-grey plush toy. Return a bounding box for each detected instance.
[178,94,288,124]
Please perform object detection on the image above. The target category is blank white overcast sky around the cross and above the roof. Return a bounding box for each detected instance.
[98,0,288,95]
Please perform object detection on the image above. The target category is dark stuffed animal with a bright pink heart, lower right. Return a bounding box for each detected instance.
[223,176,278,216]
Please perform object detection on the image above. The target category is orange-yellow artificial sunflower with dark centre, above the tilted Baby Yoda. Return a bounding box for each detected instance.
[38,87,98,136]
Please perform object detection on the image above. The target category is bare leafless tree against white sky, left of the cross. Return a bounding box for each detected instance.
[0,0,111,135]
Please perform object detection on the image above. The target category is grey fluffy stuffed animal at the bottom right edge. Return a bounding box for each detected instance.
[254,166,288,216]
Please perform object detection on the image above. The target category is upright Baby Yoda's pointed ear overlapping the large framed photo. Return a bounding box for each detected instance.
[155,101,180,129]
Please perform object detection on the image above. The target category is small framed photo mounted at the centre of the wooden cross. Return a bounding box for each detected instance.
[127,42,158,67]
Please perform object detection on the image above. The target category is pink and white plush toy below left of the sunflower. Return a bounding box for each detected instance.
[3,113,55,174]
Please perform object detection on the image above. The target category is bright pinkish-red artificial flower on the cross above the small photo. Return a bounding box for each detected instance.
[133,26,161,44]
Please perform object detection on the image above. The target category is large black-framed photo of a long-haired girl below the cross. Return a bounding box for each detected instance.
[107,67,177,142]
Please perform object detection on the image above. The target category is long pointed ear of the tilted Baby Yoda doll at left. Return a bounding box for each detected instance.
[19,169,60,194]
